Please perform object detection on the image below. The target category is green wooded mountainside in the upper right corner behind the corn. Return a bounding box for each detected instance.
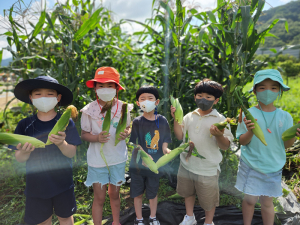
[257,0,300,47]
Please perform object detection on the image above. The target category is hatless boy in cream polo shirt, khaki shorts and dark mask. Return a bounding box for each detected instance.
[171,79,234,225]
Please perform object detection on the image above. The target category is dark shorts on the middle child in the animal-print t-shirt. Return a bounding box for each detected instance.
[130,173,159,199]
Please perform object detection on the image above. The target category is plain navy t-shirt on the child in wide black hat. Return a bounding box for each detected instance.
[10,114,81,199]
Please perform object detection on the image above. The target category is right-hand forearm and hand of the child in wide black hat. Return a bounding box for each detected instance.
[49,131,76,158]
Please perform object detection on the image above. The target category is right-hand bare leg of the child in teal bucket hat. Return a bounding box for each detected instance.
[259,196,275,225]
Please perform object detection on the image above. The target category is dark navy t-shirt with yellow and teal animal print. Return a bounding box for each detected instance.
[129,115,172,176]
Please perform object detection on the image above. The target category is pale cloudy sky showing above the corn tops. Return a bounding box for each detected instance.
[0,0,292,59]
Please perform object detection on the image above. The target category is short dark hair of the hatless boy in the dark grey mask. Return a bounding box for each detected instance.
[194,78,224,98]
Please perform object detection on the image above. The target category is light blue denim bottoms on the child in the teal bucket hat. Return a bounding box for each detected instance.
[235,159,282,197]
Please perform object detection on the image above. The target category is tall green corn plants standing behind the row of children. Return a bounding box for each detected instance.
[0,0,296,152]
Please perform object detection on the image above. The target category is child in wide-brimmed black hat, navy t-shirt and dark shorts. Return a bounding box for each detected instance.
[10,76,81,224]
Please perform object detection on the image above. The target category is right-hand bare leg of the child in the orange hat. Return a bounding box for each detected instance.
[108,184,120,225]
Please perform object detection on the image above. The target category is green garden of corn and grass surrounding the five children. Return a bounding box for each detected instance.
[0,0,300,224]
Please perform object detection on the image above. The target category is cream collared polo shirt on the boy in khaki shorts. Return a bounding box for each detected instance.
[180,109,234,176]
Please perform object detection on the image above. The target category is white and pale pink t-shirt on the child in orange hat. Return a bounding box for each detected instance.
[80,100,133,168]
